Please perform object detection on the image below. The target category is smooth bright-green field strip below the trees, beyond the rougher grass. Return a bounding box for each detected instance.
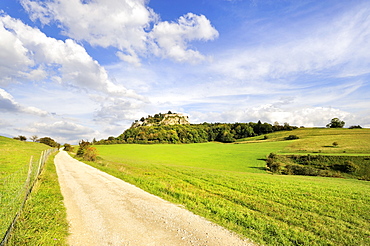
[95,142,288,173]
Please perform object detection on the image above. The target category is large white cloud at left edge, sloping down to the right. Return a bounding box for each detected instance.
[0,15,143,99]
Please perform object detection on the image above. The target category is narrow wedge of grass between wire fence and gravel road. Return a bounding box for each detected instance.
[9,154,68,246]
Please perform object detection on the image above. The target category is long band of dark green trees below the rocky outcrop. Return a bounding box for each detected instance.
[93,121,297,144]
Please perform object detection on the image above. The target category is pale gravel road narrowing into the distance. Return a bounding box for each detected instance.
[55,151,253,246]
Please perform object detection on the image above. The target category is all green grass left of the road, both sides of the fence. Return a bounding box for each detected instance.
[0,136,68,245]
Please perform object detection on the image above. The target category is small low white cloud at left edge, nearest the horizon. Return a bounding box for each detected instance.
[0,88,48,116]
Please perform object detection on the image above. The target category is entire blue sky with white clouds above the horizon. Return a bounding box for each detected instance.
[0,0,370,144]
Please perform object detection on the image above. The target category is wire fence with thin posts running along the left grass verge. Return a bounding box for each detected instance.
[0,149,57,246]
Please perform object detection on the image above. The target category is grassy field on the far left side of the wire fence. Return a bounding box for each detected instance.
[0,137,52,244]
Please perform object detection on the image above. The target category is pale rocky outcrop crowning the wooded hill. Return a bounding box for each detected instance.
[131,113,190,128]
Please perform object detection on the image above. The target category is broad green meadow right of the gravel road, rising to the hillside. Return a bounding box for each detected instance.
[90,129,370,245]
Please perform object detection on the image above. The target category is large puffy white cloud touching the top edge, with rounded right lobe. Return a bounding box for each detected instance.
[21,0,218,65]
